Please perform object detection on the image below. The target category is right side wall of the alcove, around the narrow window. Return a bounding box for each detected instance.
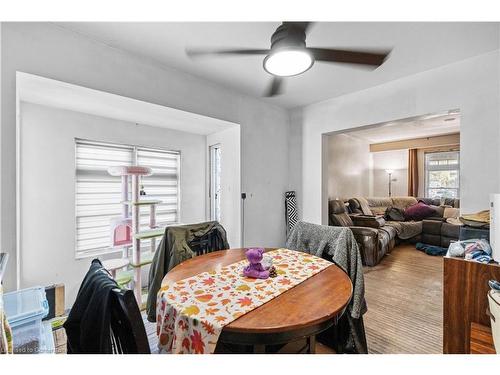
[205,127,241,248]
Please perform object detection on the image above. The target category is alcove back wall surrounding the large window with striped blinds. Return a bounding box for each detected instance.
[20,103,206,304]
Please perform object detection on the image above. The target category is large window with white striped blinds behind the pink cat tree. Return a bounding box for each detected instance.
[75,140,180,258]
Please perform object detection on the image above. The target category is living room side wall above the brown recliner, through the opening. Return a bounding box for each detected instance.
[327,134,372,199]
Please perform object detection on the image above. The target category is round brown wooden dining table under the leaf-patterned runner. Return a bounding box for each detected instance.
[162,248,352,353]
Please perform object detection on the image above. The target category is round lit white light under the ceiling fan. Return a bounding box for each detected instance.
[264,49,314,77]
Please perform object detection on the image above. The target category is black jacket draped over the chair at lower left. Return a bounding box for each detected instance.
[64,259,149,354]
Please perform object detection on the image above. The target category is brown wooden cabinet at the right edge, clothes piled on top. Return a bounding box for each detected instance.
[443,257,500,354]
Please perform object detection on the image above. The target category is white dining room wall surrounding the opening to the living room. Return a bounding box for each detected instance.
[301,51,500,223]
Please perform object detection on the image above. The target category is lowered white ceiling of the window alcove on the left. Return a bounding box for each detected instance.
[16,72,237,135]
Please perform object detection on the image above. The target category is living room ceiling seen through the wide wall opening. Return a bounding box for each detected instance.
[345,113,460,144]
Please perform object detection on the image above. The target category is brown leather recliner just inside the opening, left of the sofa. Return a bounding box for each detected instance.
[328,200,396,266]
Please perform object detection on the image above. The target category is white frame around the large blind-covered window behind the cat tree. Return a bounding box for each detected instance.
[73,137,182,260]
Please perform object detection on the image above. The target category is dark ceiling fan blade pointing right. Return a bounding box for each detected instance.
[308,48,391,66]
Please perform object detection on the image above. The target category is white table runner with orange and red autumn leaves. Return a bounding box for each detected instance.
[156,249,333,354]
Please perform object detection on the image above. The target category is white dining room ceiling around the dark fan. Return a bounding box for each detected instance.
[57,22,499,108]
